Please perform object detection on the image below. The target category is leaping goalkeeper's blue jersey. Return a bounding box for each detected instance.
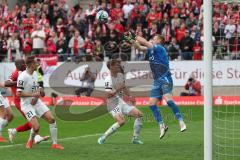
[147,45,171,80]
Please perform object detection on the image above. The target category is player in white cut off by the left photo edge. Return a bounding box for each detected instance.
[0,83,13,142]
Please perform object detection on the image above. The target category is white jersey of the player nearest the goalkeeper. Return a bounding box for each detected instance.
[105,73,124,111]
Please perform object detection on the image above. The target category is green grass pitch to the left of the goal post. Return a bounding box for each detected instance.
[0,106,203,160]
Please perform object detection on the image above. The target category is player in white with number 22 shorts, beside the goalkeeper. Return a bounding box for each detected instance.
[98,60,143,144]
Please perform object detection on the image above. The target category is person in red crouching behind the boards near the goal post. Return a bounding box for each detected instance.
[180,75,201,96]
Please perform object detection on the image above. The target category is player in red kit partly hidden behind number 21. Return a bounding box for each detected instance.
[5,59,49,148]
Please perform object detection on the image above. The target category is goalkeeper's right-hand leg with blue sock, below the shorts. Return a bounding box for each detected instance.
[164,93,187,132]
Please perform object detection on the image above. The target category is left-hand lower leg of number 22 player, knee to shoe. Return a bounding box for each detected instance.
[98,114,125,144]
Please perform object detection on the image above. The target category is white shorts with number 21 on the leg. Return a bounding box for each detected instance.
[21,100,49,120]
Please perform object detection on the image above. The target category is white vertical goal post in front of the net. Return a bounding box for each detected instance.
[203,0,213,160]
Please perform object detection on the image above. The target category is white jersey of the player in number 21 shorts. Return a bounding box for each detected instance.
[17,70,38,106]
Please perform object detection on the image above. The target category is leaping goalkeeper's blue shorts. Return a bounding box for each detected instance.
[150,77,173,99]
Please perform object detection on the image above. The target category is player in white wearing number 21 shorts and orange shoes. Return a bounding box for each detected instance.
[17,57,64,150]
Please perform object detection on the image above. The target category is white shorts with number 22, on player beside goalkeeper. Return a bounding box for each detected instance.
[109,99,135,117]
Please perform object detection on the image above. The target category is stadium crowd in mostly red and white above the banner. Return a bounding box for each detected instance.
[0,0,240,61]
